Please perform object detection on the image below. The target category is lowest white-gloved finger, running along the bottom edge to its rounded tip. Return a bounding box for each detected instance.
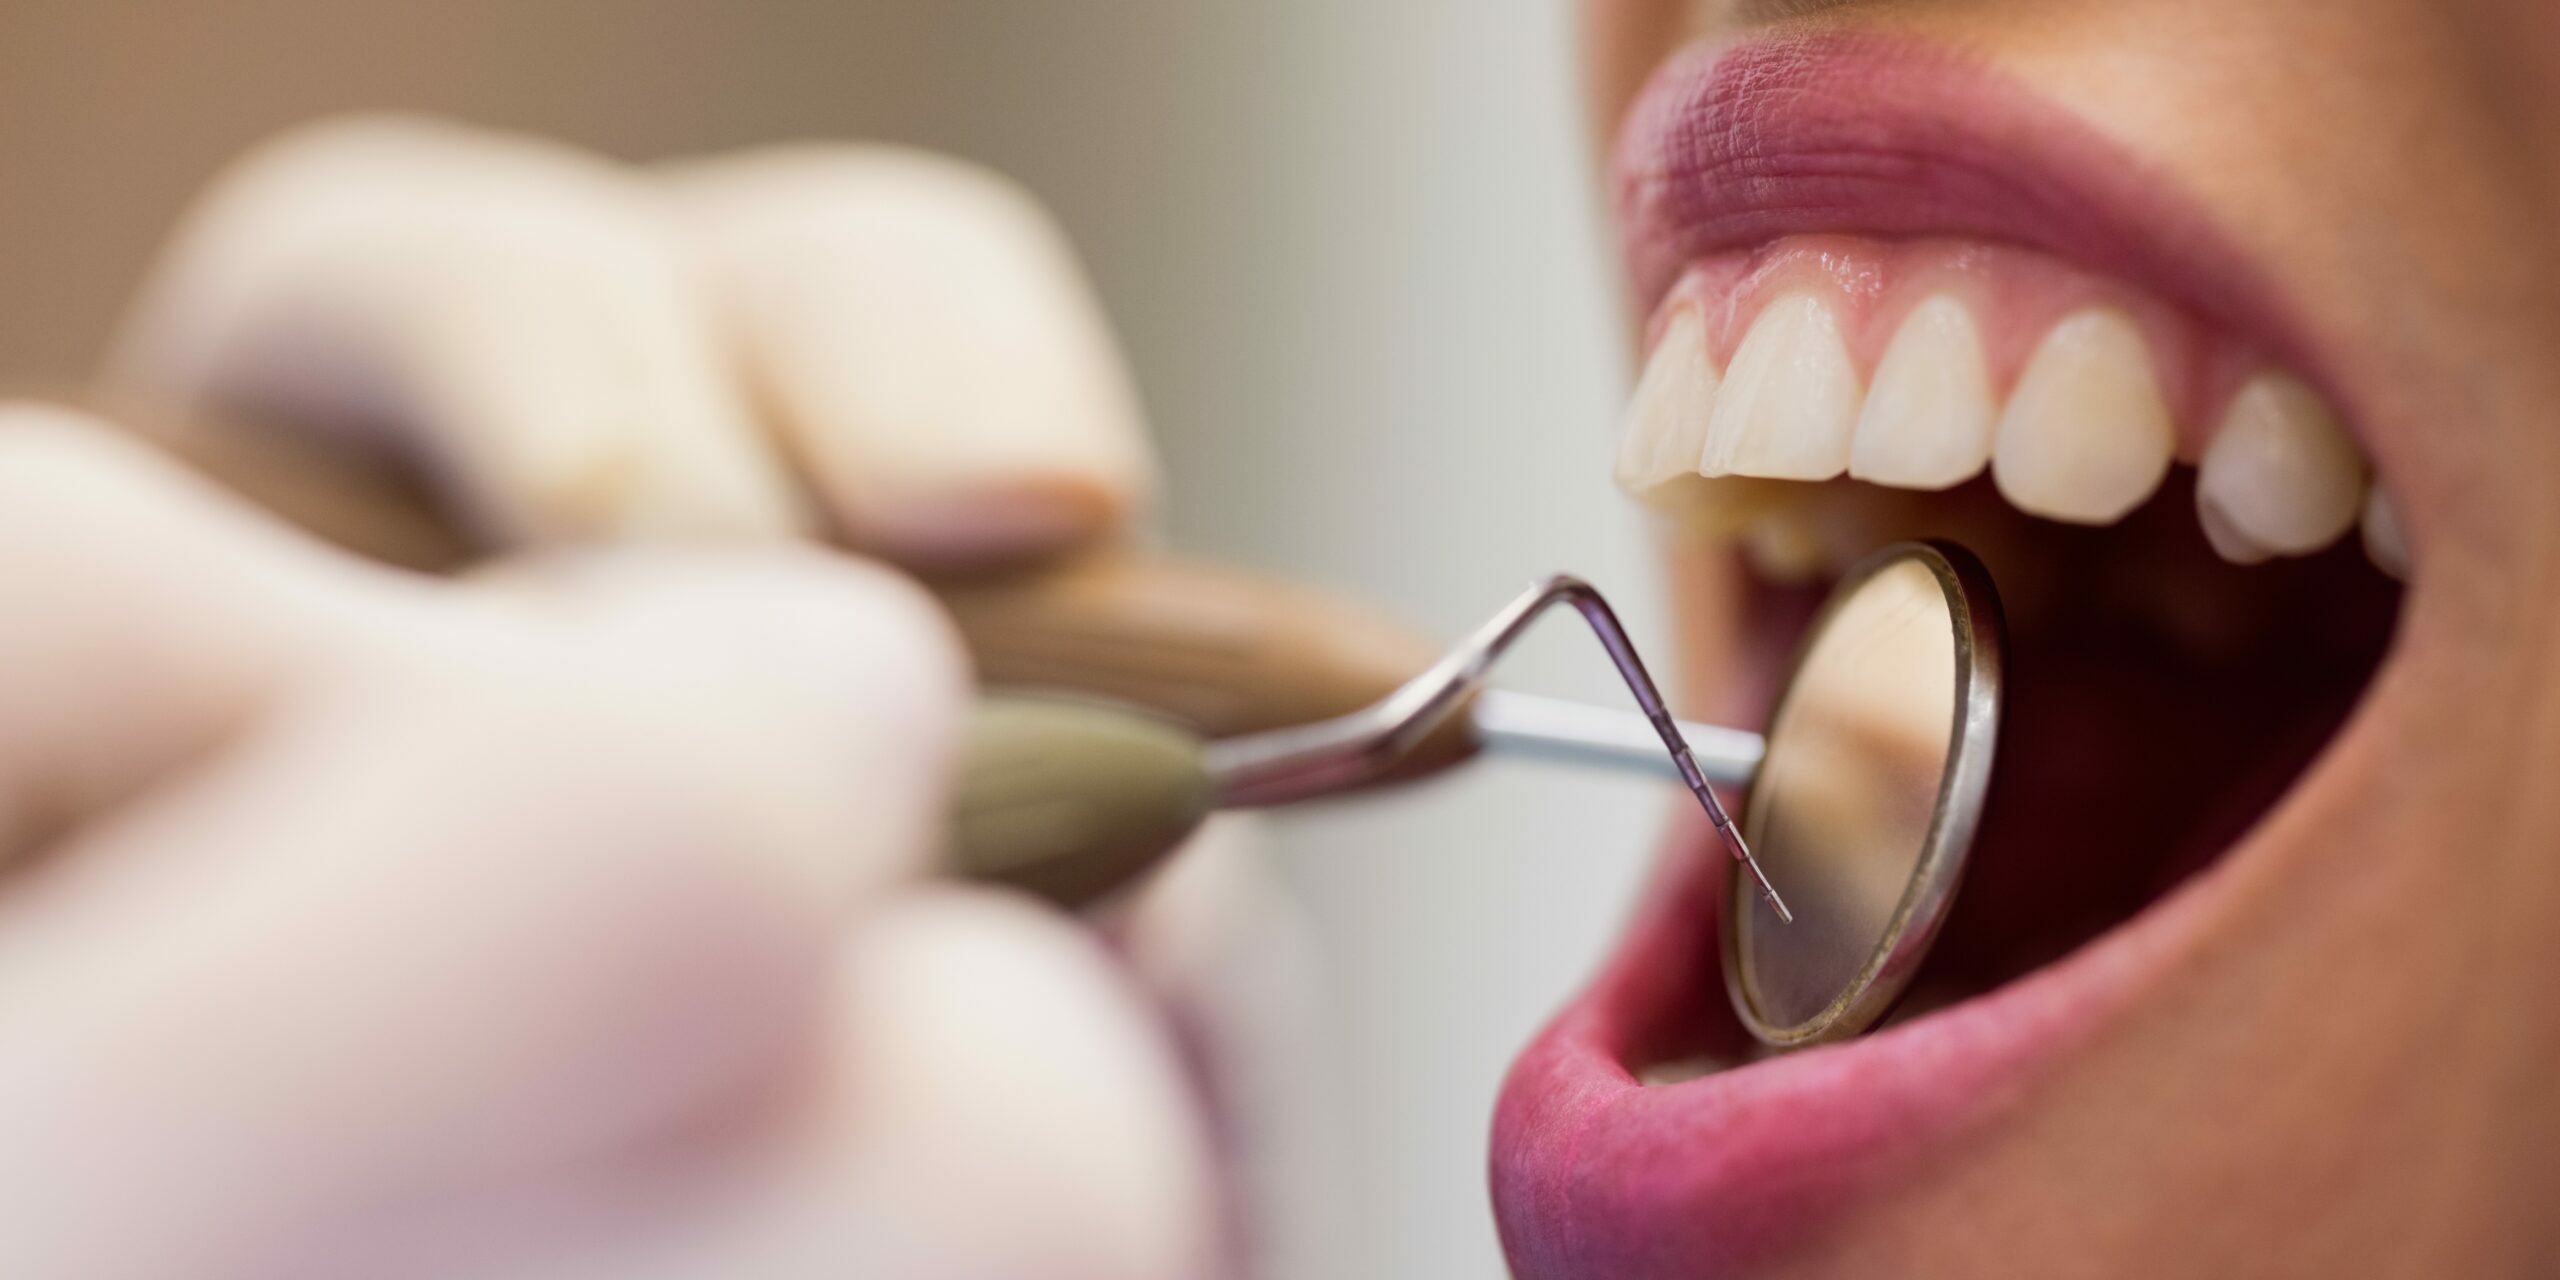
[345,888,1226,1280]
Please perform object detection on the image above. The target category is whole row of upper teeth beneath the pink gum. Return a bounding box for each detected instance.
[1618,292,2409,581]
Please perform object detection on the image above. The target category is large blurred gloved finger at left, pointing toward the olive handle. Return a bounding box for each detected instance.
[0,537,965,1275]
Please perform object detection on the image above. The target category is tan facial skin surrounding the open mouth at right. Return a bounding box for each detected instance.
[1495,0,2560,1275]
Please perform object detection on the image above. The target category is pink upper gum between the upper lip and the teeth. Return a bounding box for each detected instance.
[1646,236,2266,463]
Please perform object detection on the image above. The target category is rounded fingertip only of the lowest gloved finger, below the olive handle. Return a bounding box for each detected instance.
[804,891,1219,1280]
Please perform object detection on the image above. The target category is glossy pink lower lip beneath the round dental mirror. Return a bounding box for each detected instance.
[1492,822,2202,1277]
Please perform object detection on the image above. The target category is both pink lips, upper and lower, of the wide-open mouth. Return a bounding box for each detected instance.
[1492,36,2317,1280]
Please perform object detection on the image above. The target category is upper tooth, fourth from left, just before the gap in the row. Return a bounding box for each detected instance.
[1992,310,2176,525]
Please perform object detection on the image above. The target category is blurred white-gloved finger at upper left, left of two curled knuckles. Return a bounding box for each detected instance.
[108,118,806,555]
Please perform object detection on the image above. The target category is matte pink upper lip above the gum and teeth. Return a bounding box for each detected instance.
[1613,36,2319,379]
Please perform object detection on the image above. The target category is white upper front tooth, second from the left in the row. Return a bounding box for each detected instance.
[1697,294,1859,481]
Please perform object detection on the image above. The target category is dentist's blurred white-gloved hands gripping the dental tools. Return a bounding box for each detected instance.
[0,120,1320,1277]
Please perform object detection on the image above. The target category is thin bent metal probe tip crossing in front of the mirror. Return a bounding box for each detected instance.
[1208,573,1795,924]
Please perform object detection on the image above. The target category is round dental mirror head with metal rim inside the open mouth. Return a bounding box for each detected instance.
[1723,543,2002,1047]
